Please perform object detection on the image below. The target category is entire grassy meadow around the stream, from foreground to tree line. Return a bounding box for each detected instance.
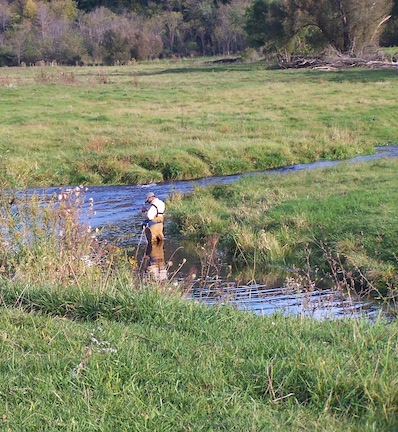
[0,60,398,432]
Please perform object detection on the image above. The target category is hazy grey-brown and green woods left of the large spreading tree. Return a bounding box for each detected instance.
[0,0,247,64]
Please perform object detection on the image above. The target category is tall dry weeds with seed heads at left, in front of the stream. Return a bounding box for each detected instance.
[0,181,131,287]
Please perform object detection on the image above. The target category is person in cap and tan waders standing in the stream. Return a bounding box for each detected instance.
[141,192,166,246]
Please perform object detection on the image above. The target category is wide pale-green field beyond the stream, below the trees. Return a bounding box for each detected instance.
[0,60,398,187]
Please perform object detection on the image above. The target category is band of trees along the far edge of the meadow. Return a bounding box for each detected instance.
[0,0,398,66]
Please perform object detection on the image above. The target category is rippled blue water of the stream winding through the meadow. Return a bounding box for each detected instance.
[46,146,398,319]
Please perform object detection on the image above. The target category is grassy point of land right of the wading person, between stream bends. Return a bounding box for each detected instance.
[168,160,398,296]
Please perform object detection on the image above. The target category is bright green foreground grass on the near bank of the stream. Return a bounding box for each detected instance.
[0,284,398,432]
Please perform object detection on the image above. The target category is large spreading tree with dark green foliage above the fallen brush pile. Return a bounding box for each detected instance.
[246,0,392,56]
